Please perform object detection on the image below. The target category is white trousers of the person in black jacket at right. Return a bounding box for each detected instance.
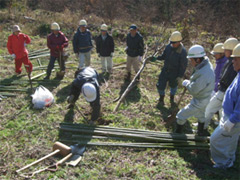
[204,91,225,129]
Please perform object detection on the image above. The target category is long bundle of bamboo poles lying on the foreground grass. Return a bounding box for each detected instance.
[59,123,209,149]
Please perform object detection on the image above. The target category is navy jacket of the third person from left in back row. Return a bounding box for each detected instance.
[73,28,93,53]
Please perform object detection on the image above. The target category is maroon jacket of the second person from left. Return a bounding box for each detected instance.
[47,31,68,57]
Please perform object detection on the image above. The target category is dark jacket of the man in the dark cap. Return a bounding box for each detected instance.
[127,32,144,57]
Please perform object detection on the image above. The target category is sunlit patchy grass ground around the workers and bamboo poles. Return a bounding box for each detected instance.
[0,11,240,180]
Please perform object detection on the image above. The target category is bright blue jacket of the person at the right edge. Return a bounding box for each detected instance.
[223,71,240,123]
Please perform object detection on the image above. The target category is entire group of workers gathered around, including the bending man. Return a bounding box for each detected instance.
[7,19,240,168]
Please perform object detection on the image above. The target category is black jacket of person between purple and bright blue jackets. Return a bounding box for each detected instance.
[218,58,237,92]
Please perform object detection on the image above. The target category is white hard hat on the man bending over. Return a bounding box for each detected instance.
[82,83,97,102]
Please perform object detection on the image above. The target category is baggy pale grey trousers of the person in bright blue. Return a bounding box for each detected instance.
[210,113,240,167]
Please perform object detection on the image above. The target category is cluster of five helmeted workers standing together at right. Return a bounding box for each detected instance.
[150,35,240,169]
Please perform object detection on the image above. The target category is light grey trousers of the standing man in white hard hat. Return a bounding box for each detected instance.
[176,98,209,125]
